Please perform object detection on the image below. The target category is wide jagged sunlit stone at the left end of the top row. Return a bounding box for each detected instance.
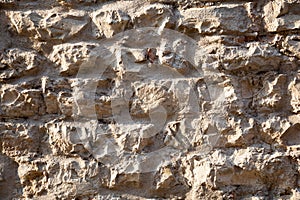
[9,11,89,40]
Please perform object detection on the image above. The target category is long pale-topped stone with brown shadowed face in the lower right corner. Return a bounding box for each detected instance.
[194,146,297,195]
